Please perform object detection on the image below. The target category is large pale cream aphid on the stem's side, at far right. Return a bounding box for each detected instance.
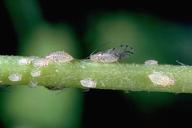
[148,72,175,87]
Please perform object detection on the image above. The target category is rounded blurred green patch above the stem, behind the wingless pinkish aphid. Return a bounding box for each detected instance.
[19,23,81,58]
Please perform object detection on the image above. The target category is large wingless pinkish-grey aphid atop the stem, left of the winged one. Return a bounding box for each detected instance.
[45,51,73,62]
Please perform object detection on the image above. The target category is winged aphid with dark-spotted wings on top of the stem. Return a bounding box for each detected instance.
[90,45,133,63]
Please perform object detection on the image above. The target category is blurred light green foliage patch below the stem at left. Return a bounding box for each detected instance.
[3,87,82,128]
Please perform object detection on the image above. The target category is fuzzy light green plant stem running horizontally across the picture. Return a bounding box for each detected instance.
[0,56,192,93]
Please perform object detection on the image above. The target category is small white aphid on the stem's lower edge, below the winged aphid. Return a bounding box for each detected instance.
[80,78,97,88]
